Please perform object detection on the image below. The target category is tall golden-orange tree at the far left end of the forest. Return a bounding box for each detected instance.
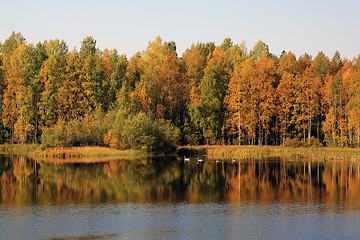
[3,43,37,143]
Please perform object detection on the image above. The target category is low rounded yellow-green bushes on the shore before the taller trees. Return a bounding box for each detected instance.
[41,109,180,153]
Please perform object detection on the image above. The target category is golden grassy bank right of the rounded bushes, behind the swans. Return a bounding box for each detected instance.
[178,146,360,161]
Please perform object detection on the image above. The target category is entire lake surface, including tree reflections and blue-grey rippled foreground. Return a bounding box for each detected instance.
[0,156,360,239]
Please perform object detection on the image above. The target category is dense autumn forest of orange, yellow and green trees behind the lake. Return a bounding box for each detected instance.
[0,32,360,152]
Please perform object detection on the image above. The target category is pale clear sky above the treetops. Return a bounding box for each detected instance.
[0,0,360,59]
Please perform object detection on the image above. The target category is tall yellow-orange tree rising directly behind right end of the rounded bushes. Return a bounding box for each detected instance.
[132,37,179,118]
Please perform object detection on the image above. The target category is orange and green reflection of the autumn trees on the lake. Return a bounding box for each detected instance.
[0,156,360,207]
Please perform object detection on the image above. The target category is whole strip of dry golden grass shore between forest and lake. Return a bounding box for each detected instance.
[0,144,360,162]
